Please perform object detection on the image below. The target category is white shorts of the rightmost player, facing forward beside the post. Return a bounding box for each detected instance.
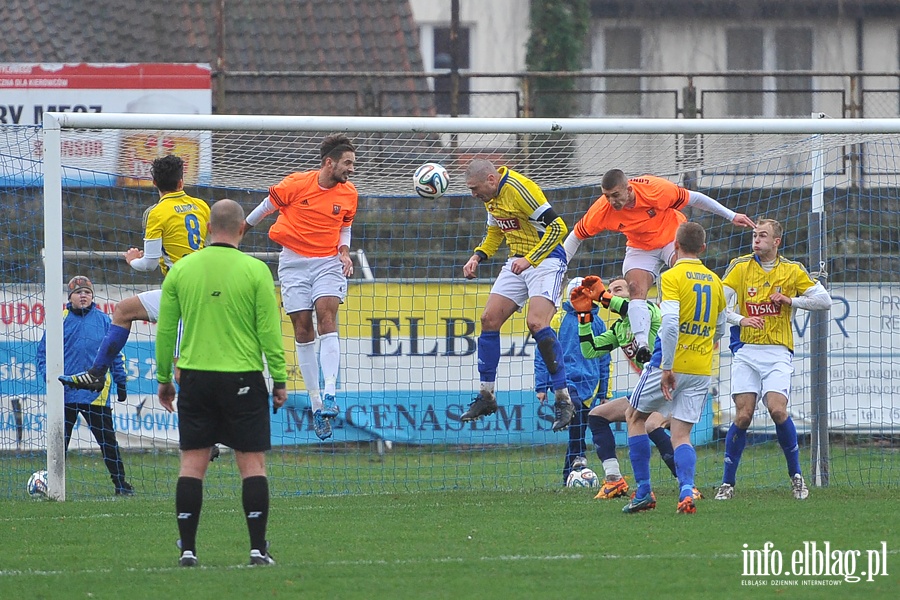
[731,344,794,400]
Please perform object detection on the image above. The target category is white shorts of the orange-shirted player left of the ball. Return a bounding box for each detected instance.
[278,248,347,314]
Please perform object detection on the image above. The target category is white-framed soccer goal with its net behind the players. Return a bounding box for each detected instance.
[0,114,900,499]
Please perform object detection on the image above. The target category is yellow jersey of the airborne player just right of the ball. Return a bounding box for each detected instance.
[475,167,569,266]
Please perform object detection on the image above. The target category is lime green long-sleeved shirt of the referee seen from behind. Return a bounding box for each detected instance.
[156,244,287,383]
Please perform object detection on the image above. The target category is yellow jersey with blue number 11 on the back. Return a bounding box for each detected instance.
[660,258,725,375]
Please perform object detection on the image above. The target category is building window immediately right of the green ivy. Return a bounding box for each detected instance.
[603,28,641,116]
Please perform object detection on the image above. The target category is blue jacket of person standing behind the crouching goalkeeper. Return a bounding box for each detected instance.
[534,300,610,406]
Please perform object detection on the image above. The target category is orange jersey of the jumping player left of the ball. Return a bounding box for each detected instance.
[269,171,359,258]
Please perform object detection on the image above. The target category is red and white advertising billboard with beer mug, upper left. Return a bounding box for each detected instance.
[0,63,212,186]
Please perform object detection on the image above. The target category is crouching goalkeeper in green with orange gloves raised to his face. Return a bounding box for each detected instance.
[569,275,702,500]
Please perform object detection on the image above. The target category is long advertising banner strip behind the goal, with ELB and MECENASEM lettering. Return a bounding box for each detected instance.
[10,282,900,449]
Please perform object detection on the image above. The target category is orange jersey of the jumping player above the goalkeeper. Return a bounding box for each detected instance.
[575,175,690,250]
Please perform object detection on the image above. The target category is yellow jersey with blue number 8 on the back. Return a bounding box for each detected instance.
[144,190,209,275]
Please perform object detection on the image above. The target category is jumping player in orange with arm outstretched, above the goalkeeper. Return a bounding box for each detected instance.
[564,169,753,362]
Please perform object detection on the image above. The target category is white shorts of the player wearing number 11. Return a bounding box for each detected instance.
[631,365,710,423]
